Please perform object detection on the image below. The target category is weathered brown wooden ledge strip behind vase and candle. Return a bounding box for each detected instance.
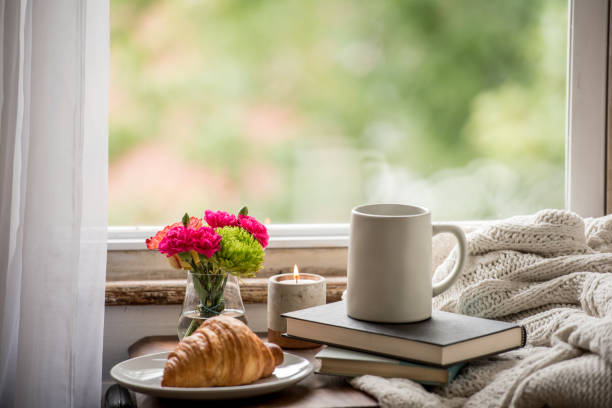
[106,276,346,306]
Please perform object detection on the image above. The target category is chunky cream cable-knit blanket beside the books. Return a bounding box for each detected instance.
[351,210,612,407]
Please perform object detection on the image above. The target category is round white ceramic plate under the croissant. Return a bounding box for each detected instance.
[111,352,312,399]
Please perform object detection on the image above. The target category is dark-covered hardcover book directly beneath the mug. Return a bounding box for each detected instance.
[283,301,526,367]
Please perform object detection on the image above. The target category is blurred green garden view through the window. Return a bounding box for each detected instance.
[109,0,567,225]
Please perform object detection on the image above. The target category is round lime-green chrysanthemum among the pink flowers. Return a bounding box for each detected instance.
[211,227,264,278]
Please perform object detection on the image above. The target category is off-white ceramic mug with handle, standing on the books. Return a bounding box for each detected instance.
[346,204,466,323]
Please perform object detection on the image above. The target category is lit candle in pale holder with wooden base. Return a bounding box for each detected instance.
[268,273,326,348]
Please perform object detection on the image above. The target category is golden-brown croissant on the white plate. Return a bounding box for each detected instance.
[162,316,283,387]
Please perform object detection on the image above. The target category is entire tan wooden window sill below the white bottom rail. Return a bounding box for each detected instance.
[106,225,472,306]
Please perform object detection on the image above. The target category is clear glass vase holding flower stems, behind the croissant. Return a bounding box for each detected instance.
[178,272,244,340]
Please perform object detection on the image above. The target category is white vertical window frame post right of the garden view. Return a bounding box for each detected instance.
[565,0,610,217]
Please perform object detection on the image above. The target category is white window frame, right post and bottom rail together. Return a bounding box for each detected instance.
[108,0,610,251]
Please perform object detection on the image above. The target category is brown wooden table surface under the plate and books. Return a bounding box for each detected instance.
[128,336,378,408]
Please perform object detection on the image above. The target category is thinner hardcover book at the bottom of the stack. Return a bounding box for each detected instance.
[315,347,465,385]
